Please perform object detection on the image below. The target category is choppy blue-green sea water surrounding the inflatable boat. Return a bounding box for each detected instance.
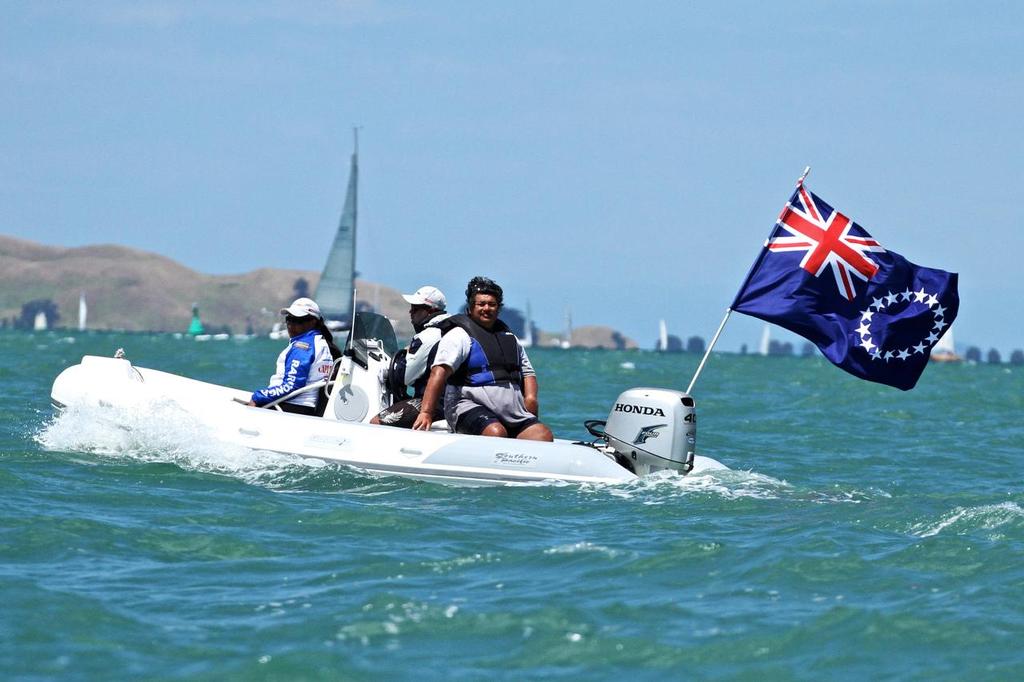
[0,332,1024,681]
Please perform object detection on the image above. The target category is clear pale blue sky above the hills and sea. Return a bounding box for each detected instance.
[0,0,1024,355]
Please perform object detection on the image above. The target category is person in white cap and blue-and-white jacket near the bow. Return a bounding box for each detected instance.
[249,298,341,415]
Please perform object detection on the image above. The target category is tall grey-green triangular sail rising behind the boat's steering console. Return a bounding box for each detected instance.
[313,138,359,329]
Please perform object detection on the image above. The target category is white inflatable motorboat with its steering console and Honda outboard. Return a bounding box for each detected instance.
[50,312,724,485]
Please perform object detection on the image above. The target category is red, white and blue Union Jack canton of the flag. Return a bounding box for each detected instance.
[765,183,885,301]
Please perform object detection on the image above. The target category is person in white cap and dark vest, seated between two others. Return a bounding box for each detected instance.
[370,286,449,429]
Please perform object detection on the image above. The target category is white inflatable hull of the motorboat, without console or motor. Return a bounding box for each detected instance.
[51,356,721,485]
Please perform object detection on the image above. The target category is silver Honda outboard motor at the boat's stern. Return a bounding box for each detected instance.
[604,388,697,476]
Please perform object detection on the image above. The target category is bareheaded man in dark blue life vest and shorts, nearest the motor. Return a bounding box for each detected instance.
[413,278,554,440]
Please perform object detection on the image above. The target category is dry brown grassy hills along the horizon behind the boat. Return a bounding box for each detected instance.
[0,235,636,348]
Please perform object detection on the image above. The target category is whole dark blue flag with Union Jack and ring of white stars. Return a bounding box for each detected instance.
[731,182,959,390]
